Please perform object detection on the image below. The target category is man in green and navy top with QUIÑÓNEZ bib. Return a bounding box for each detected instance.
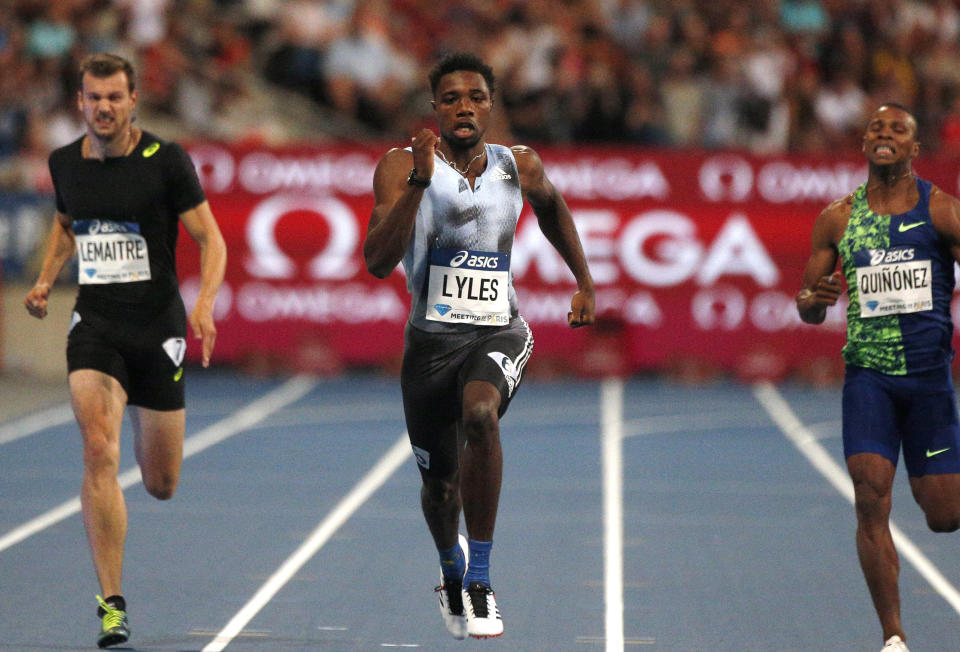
[797,104,960,652]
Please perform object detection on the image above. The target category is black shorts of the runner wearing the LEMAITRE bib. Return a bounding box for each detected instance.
[67,296,187,410]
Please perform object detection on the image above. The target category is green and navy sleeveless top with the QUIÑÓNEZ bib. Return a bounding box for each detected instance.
[838,179,954,375]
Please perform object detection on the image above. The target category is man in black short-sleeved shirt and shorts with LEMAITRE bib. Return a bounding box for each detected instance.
[24,54,226,647]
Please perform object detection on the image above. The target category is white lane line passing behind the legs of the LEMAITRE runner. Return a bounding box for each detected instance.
[0,376,319,552]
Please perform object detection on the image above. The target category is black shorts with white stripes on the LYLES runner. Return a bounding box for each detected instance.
[400,317,533,477]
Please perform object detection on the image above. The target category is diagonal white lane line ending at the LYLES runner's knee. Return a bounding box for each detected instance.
[202,432,410,652]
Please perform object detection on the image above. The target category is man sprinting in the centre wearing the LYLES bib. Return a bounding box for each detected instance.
[363,53,594,639]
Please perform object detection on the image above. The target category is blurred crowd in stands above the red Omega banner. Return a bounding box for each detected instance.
[0,0,960,188]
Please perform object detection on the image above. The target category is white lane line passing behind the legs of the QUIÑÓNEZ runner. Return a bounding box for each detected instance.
[753,383,960,614]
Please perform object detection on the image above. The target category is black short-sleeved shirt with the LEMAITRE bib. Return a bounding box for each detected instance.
[50,131,205,322]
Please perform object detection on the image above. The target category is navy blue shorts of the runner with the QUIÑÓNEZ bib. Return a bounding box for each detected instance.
[843,365,960,477]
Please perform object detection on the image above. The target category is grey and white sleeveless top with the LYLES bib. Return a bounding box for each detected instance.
[403,144,523,333]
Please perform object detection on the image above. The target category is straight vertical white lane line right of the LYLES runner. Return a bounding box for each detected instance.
[600,378,624,652]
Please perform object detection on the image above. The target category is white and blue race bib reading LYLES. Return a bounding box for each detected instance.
[426,248,510,326]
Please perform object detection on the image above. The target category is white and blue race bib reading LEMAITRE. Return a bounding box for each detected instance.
[73,220,150,285]
